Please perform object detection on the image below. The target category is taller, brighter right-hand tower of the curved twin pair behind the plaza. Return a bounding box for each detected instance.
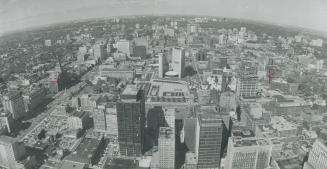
[172,48,185,78]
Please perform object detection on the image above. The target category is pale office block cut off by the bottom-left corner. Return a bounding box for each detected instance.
[0,135,25,169]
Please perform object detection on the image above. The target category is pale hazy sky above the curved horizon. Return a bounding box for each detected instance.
[0,0,327,35]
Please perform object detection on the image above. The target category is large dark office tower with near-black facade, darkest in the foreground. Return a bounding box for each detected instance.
[116,85,145,157]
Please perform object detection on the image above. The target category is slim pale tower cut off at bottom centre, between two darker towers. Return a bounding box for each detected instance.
[158,127,175,169]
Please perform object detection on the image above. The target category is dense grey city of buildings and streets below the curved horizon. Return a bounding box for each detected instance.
[0,2,327,169]
